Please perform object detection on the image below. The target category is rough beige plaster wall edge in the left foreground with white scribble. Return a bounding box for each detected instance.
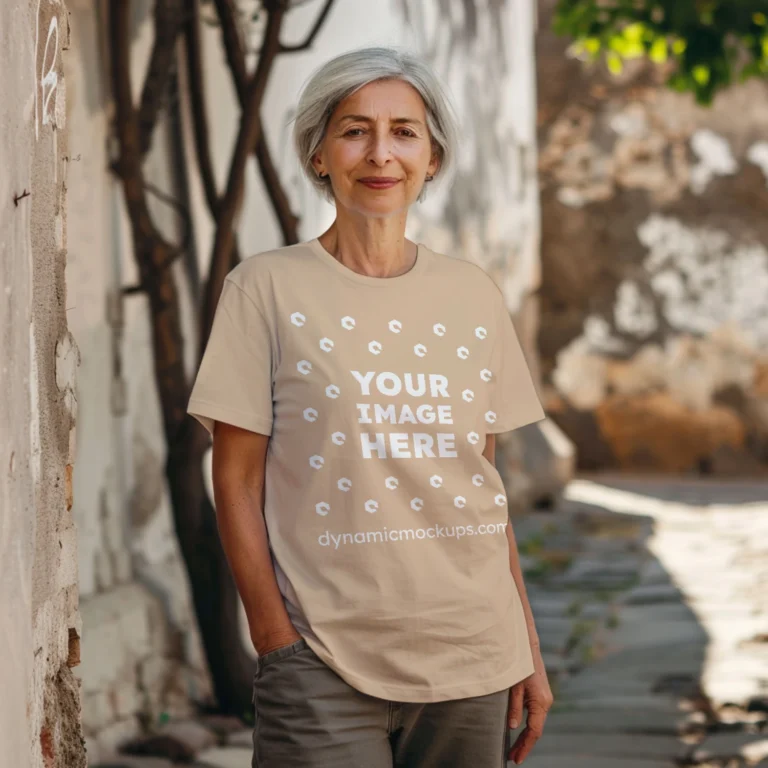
[0,0,85,768]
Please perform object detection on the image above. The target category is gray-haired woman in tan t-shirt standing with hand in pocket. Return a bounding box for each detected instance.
[188,48,552,768]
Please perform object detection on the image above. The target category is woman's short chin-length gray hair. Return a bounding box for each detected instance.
[293,47,459,201]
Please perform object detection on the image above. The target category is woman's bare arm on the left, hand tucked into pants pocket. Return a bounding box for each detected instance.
[213,421,301,656]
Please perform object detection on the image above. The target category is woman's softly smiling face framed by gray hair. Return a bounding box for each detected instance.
[313,80,438,218]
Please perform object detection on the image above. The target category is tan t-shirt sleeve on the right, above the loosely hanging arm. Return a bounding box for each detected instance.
[486,303,546,434]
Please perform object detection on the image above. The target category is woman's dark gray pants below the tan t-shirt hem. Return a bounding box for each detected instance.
[252,640,509,768]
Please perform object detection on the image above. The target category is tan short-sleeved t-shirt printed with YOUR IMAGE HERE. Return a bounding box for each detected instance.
[188,240,544,702]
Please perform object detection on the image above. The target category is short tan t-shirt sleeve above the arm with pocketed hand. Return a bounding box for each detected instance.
[187,279,273,435]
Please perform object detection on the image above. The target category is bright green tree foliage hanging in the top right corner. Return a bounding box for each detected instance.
[554,0,768,104]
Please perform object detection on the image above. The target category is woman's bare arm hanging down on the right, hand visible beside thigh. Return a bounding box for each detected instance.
[483,435,553,765]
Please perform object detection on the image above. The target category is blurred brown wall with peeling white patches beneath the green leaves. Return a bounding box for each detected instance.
[537,0,768,473]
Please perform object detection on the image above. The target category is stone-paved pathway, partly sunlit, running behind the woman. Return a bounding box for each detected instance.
[88,476,768,768]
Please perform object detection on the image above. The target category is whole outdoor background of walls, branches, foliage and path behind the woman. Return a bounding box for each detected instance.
[0,0,768,768]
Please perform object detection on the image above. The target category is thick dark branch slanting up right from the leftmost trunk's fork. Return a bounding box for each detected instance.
[138,0,185,155]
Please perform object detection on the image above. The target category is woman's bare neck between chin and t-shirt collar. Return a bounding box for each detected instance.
[318,209,417,277]
